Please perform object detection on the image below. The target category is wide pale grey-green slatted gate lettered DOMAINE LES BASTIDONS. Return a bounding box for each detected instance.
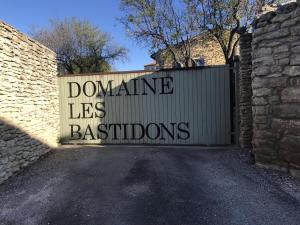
[59,66,231,145]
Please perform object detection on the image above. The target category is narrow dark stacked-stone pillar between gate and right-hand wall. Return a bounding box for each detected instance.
[239,34,253,148]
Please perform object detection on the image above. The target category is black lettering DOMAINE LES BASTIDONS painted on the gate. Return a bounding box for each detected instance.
[67,76,190,140]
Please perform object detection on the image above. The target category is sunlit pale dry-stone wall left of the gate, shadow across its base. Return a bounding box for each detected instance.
[0,21,59,183]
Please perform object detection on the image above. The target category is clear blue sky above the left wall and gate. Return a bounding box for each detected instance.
[0,0,152,71]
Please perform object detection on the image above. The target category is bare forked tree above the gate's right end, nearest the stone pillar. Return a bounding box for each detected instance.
[185,0,256,64]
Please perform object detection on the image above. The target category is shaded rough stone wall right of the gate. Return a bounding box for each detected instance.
[252,2,300,176]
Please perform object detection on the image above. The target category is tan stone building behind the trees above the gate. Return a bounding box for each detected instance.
[144,35,238,70]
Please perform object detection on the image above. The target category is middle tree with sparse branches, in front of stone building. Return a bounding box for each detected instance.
[119,0,199,67]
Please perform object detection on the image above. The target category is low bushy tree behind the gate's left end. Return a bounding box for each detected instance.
[32,18,127,73]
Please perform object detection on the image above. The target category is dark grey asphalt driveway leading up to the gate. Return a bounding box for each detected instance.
[0,146,300,225]
